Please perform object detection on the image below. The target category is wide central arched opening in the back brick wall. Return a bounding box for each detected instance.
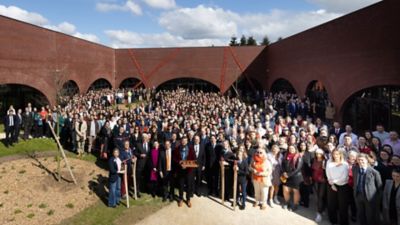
[157,78,219,92]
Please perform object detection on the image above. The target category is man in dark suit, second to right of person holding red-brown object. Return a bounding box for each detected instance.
[206,135,219,196]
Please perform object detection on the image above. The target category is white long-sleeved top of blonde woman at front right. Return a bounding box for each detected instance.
[325,160,349,186]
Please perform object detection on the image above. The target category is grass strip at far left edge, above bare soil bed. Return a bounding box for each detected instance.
[0,138,57,157]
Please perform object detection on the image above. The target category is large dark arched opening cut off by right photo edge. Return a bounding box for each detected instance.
[342,86,400,131]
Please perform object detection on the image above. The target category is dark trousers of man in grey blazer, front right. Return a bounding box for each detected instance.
[355,193,379,225]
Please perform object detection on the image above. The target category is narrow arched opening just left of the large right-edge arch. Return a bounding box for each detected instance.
[306,80,329,120]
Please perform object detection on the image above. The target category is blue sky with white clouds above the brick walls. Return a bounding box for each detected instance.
[0,0,379,48]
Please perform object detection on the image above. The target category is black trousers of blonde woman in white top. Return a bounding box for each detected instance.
[328,184,349,225]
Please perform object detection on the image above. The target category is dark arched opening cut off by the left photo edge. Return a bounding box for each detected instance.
[0,84,49,116]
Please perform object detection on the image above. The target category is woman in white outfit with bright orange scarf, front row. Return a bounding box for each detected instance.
[250,147,272,210]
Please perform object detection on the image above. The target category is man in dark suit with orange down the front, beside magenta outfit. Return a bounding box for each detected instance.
[158,140,174,202]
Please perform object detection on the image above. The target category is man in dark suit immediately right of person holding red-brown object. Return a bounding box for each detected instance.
[192,135,206,196]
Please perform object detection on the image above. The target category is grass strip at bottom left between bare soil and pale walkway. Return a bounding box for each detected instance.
[60,195,168,225]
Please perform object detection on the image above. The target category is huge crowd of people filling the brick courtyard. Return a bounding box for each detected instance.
[4,86,400,225]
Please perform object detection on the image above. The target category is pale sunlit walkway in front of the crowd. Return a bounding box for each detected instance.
[134,197,330,225]
